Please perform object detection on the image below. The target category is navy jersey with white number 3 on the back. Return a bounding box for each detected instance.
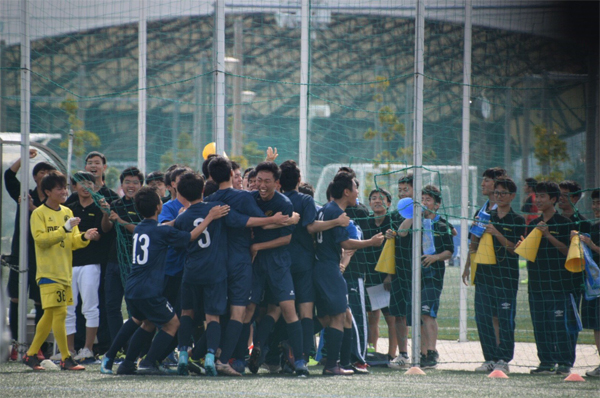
[175,202,248,284]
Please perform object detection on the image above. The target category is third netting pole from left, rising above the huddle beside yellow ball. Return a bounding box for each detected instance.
[213,0,226,154]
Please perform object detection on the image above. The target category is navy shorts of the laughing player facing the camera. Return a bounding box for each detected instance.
[250,250,296,304]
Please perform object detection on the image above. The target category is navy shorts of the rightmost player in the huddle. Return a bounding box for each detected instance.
[313,263,348,317]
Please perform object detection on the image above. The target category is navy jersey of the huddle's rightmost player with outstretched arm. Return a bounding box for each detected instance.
[315,201,350,269]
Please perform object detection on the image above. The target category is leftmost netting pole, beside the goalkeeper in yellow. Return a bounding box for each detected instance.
[19,0,31,359]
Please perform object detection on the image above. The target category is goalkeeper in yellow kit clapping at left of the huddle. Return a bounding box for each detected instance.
[23,171,98,370]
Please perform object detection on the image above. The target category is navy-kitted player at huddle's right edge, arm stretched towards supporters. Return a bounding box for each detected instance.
[314,171,384,375]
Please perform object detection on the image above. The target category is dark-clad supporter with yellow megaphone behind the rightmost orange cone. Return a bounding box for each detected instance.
[527,181,582,375]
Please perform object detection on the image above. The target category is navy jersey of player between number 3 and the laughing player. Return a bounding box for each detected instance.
[204,188,265,270]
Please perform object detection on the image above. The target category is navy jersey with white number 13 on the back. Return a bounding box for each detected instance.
[125,219,190,299]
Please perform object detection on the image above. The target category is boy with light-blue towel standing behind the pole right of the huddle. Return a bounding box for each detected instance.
[399,185,454,368]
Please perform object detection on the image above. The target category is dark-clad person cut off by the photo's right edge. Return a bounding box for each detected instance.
[579,189,600,377]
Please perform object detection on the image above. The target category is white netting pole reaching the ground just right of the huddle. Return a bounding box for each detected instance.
[411,0,425,366]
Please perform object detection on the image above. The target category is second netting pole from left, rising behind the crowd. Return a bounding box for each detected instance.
[138,0,148,175]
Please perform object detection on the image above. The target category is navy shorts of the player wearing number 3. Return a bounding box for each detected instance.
[181,279,227,315]
